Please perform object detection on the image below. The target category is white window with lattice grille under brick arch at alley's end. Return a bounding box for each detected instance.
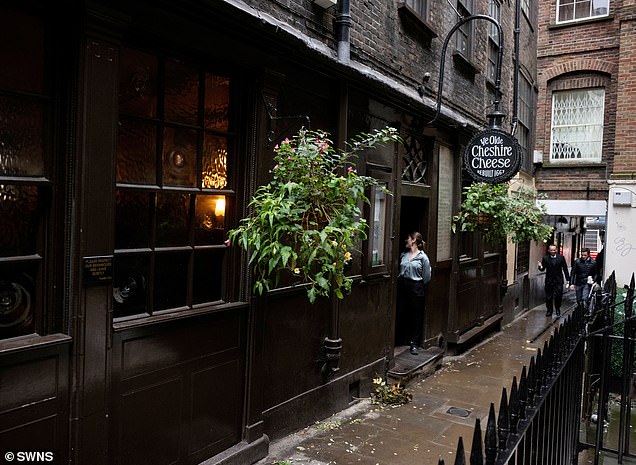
[550,87,605,164]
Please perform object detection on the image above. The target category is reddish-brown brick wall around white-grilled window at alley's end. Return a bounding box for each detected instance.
[535,0,633,199]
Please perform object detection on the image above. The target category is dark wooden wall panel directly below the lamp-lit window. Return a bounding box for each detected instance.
[111,308,247,465]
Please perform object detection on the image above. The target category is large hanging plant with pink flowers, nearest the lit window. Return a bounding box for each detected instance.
[229,128,401,303]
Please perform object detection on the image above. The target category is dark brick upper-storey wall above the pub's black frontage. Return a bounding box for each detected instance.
[238,0,536,130]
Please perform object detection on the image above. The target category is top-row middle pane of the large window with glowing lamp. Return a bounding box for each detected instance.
[164,60,199,124]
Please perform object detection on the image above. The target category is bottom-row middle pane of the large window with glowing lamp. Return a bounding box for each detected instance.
[154,252,188,310]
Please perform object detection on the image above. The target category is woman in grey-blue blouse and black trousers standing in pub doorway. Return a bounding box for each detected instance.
[398,231,431,355]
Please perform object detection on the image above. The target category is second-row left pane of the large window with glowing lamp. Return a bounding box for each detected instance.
[117,121,157,184]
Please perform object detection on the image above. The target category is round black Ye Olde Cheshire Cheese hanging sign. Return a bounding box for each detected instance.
[464,129,521,184]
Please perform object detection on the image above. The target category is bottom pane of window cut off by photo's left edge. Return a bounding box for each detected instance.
[0,263,38,339]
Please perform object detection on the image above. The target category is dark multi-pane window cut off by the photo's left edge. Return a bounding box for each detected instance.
[0,6,49,339]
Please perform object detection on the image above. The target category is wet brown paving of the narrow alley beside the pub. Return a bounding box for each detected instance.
[258,300,576,465]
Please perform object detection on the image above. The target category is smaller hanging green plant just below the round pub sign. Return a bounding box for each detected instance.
[452,182,552,243]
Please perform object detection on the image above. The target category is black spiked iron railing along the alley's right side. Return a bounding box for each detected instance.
[439,273,636,465]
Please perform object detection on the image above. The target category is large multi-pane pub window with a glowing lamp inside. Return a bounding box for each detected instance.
[113,48,235,318]
